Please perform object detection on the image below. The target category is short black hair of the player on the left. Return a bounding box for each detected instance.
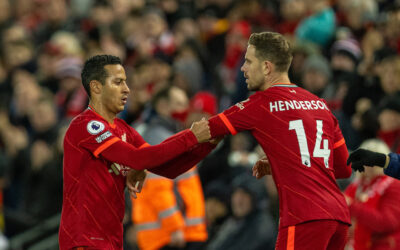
[81,55,122,97]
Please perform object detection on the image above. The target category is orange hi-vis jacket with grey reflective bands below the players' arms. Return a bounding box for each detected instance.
[132,168,208,250]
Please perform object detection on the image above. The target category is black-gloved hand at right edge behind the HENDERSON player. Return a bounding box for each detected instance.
[347,148,386,172]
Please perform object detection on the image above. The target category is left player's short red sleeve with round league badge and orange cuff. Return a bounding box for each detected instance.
[74,119,121,157]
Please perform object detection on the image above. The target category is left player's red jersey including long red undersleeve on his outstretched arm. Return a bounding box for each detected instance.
[59,109,197,250]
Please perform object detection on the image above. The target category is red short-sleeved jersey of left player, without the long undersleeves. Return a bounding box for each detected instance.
[59,109,145,249]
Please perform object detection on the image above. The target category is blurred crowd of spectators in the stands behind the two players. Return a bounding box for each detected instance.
[0,0,400,249]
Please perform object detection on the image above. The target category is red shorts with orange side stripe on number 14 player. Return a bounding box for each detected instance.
[275,220,349,250]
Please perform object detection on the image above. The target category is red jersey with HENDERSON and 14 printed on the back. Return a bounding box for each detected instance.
[210,84,351,228]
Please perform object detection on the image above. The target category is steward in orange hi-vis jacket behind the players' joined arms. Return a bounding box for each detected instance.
[132,87,207,250]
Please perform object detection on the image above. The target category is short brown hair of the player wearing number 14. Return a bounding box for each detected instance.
[249,32,293,72]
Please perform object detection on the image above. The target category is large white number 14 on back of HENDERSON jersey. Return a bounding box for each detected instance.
[289,120,331,168]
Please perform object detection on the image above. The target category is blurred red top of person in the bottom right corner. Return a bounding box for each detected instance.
[345,176,400,250]
